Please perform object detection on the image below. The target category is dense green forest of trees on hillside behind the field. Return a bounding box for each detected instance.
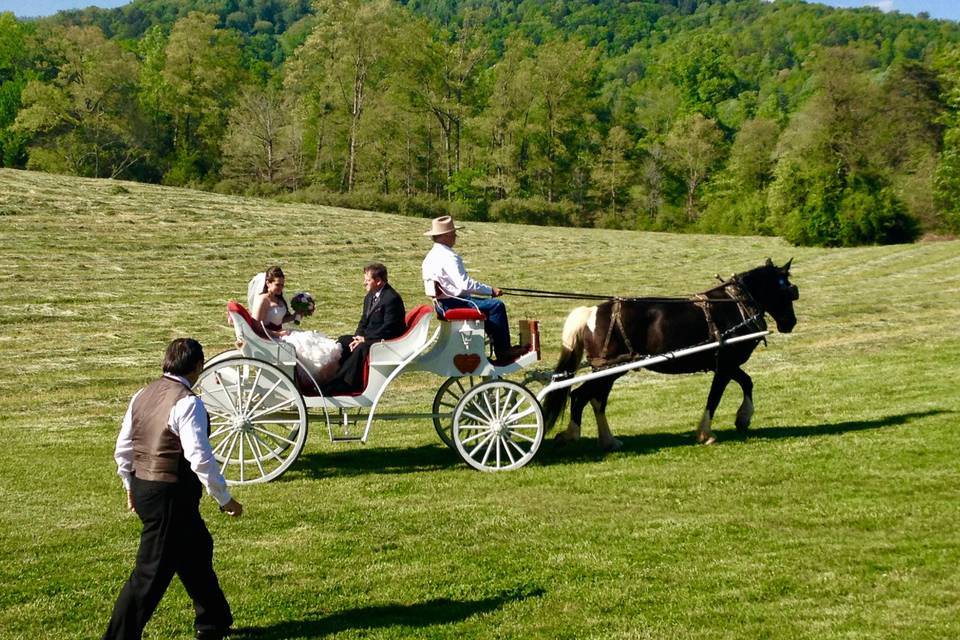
[0,0,960,246]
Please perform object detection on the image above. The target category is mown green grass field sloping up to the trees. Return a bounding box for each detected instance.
[0,170,960,640]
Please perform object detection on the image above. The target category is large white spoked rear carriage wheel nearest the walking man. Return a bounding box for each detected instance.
[194,358,307,484]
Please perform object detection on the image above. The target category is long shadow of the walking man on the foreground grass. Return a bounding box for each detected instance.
[230,586,546,640]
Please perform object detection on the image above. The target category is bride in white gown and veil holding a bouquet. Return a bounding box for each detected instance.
[247,267,342,383]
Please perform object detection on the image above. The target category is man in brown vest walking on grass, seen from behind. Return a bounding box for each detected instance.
[103,338,243,640]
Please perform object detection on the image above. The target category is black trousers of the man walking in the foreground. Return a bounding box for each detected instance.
[103,474,233,640]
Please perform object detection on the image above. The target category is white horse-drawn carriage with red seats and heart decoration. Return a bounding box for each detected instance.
[195,302,544,484]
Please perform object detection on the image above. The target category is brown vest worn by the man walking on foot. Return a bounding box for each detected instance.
[131,377,199,482]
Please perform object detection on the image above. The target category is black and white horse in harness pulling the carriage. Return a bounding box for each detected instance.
[544,259,800,450]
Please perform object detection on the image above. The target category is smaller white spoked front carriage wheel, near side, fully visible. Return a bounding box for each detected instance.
[453,380,543,471]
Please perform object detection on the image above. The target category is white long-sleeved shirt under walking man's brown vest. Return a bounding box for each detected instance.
[113,373,231,507]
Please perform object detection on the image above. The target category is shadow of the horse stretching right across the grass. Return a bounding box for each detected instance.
[536,409,954,465]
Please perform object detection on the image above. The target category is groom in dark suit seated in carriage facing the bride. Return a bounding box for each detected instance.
[321,262,407,396]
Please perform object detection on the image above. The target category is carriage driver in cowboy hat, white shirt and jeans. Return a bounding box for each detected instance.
[422,216,523,364]
